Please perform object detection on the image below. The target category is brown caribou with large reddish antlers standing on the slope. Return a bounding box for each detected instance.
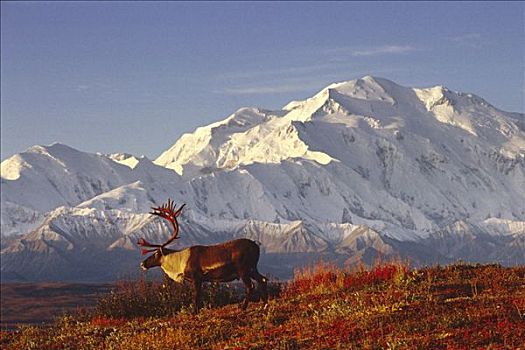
[137,199,268,313]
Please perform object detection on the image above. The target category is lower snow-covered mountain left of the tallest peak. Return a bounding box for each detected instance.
[1,143,178,236]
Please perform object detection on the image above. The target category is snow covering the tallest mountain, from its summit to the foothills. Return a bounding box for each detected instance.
[149,77,525,235]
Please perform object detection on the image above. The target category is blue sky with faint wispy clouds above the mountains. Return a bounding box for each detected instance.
[1,1,525,159]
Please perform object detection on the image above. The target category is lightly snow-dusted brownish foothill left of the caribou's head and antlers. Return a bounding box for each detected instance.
[1,207,163,281]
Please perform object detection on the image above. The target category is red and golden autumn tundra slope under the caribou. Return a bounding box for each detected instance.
[0,262,525,349]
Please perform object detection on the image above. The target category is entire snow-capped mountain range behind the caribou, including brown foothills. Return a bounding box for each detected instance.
[1,76,525,279]
